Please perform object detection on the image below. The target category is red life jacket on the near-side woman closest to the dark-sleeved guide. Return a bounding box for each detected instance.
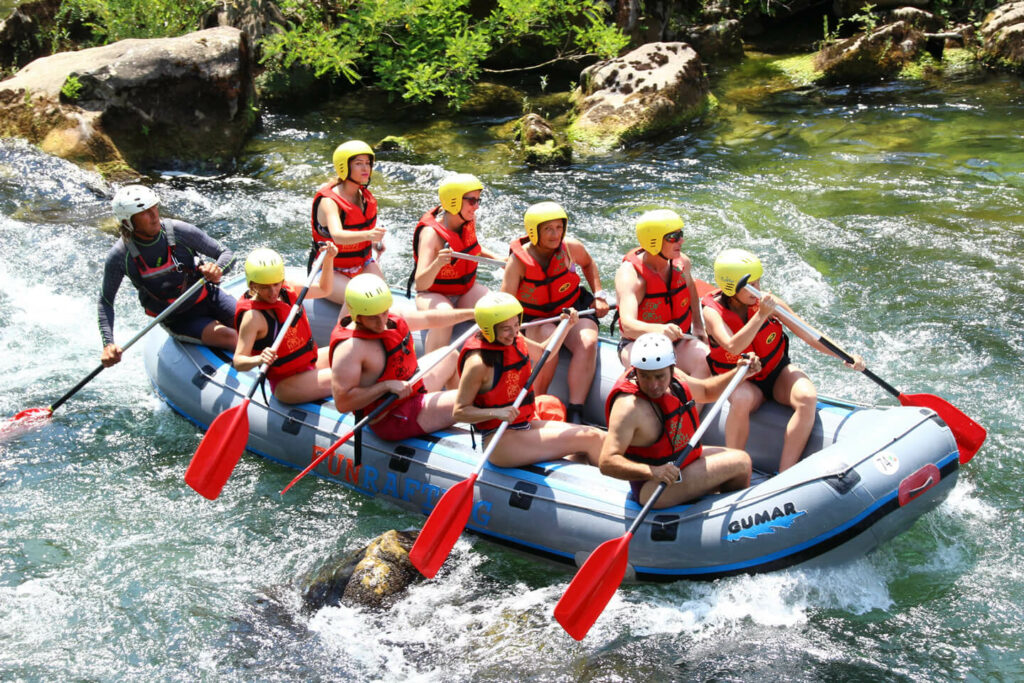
[234,283,316,383]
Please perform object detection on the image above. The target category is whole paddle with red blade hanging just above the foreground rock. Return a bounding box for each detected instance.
[409,318,569,579]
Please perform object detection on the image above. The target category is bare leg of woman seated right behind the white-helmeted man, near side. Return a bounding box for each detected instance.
[490,420,604,467]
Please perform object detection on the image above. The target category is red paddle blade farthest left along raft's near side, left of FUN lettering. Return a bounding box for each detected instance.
[185,398,249,501]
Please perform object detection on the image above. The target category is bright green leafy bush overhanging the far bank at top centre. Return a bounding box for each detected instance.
[260,0,628,108]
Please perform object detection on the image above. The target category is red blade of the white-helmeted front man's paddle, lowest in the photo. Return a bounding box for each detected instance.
[555,532,633,640]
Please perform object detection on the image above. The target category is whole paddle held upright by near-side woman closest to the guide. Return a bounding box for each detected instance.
[185,252,327,501]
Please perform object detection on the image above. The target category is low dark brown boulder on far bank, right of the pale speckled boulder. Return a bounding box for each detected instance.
[814,22,926,83]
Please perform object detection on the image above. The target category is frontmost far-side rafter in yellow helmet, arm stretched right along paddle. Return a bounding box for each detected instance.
[702,249,864,472]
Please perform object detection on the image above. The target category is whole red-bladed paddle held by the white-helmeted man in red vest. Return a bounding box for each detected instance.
[555,366,748,640]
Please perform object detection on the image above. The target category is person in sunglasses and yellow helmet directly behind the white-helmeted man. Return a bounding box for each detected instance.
[615,209,711,378]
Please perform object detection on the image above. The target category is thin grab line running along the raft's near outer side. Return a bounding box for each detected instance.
[185,353,946,529]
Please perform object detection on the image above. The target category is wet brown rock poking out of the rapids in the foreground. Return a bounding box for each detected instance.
[300,529,422,609]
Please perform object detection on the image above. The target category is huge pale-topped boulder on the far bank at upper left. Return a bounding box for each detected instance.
[0,28,256,175]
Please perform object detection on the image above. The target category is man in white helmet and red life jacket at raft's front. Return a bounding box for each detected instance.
[600,333,761,508]
